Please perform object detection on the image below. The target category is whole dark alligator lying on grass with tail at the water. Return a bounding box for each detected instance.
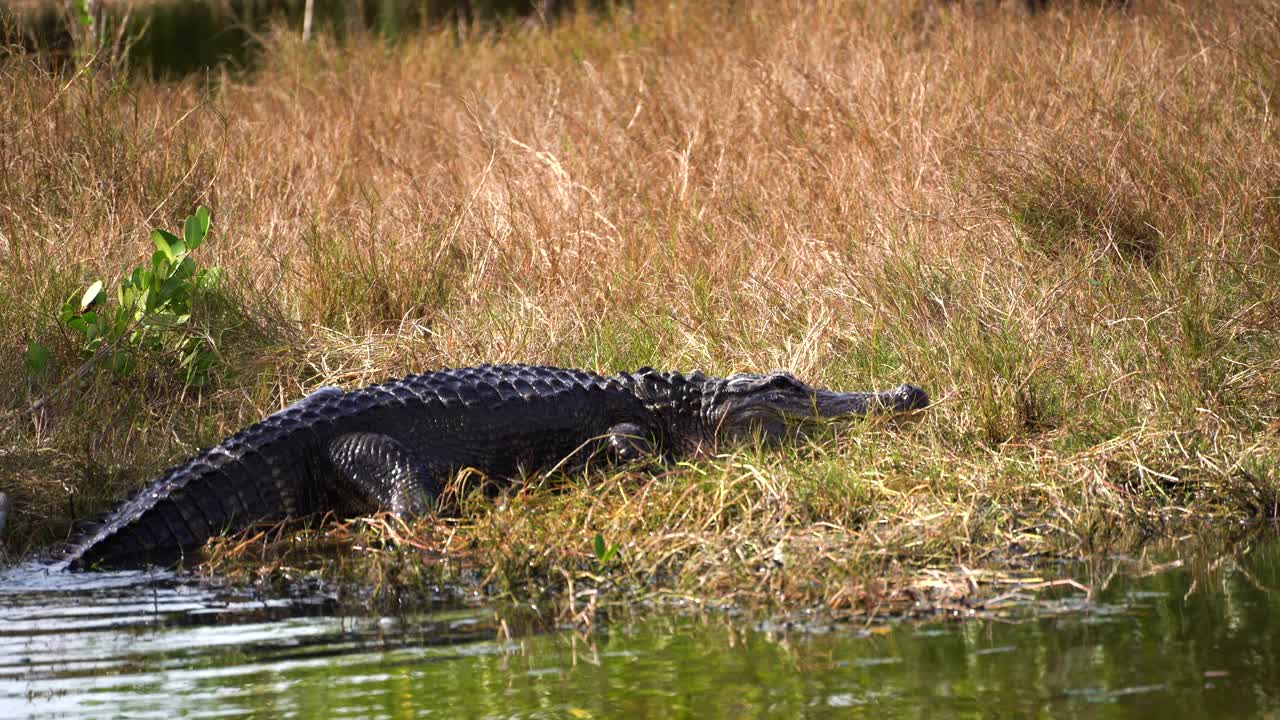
[59,365,929,570]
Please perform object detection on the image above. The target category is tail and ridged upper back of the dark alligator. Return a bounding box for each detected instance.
[64,365,635,566]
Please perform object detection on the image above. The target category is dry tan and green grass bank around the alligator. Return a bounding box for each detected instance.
[0,0,1280,614]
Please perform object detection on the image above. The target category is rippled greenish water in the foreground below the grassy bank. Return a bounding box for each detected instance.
[0,542,1280,720]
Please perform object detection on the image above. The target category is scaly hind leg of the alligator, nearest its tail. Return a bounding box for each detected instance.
[328,433,442,518]
